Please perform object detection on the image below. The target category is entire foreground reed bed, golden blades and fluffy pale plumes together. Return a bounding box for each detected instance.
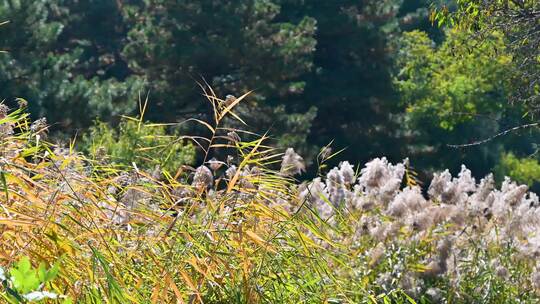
[0,93,540,303]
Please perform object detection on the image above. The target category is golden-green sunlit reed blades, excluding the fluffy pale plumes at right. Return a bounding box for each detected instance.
[0,88,537,303]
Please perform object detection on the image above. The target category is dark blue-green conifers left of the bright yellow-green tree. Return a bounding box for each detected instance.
[0,0,427,159]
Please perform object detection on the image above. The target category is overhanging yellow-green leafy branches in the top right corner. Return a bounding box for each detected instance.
[431,0,540,107]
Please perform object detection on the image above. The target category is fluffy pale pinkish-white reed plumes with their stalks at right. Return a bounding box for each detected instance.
[299,158,540,302]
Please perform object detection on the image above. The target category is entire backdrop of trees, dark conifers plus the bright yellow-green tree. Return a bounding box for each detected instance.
[0,0,538,185]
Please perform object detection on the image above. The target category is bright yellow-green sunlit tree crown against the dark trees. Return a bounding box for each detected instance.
[396,31,510,131]
